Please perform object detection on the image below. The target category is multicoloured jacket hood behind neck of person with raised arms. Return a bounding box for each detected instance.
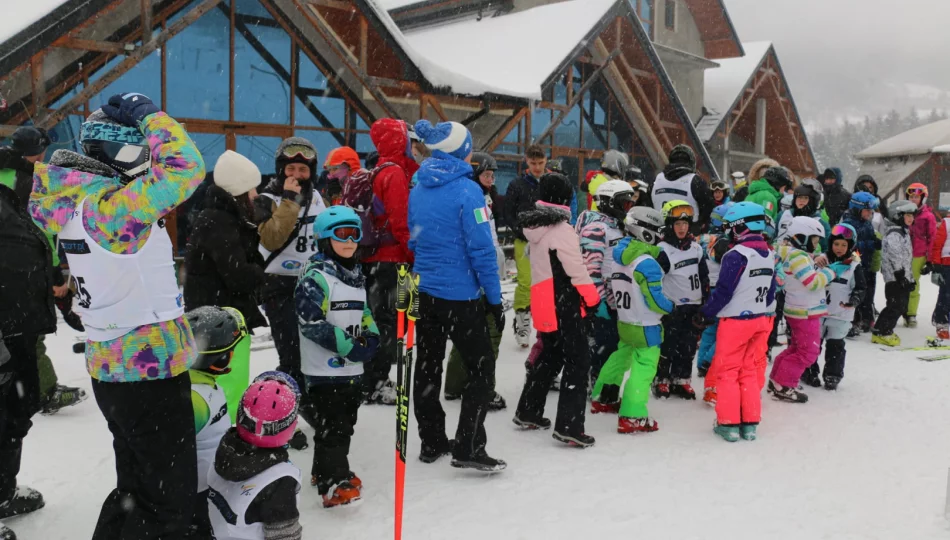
[30,150,122,228]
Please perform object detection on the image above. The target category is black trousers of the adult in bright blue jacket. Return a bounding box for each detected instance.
[412,292,495,459]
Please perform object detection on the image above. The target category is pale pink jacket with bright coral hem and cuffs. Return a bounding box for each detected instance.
[519,202,600,332]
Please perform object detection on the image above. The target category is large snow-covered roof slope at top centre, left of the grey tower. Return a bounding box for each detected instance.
[368,0,618,99]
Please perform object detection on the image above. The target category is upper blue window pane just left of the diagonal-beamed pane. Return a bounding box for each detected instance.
[165,5,231,120]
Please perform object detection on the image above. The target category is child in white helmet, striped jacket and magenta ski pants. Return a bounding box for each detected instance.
[769,216,843,403]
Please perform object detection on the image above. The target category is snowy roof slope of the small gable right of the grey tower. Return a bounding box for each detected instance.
[696,41,772,142]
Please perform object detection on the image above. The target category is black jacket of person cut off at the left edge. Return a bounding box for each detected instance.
[0,185,56,337]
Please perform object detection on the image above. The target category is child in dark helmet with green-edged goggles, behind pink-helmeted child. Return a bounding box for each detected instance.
[185,306,247,538]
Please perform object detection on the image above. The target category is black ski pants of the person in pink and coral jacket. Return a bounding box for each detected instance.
[517,314,590,436]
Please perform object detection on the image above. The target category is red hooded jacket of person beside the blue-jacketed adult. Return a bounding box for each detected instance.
[363,118,419,263]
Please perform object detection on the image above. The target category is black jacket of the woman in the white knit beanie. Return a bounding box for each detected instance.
[185,185,267,328]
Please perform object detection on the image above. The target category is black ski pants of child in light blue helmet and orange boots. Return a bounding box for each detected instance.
[307,377,363,495]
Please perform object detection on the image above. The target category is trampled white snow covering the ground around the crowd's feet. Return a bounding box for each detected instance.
[7,281,950,540]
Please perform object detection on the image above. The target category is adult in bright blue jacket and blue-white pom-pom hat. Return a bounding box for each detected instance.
[408,120,505,471]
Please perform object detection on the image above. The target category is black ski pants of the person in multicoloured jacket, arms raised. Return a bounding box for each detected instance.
[92,373,198,540]
